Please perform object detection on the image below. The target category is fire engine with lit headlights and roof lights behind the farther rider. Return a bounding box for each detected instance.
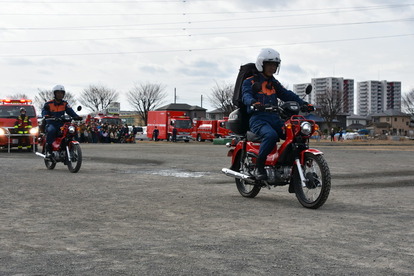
[0,99,39,152]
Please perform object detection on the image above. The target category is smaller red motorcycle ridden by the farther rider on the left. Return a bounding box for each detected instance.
[36,115,82,173]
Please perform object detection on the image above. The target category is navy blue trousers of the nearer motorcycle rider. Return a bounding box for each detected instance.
[249,112,284,160]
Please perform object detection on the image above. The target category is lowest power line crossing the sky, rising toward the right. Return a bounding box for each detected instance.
[0,33,414,58]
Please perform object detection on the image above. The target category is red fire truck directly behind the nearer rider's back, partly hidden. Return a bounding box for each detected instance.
[191,117,232,142]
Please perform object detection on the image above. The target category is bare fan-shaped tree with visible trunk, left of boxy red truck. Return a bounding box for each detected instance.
[127,83,167,125]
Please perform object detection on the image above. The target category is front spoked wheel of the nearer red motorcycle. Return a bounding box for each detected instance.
[293,153,331,209]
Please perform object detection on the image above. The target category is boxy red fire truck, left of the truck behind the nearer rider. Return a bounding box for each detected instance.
[147,111,193,142]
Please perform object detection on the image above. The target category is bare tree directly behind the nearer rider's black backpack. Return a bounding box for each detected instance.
[208,82,236,116]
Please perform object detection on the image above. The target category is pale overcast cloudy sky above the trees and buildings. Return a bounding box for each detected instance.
[0,0,414,110]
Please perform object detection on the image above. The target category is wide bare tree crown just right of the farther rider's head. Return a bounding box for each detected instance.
[78,85,119,112]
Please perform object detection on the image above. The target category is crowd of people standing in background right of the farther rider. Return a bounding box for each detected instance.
[73,122,137,143]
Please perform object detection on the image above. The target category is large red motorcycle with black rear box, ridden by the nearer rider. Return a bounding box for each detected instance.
[222,96,331,209]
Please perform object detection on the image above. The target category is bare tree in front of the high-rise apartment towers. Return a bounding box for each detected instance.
[316,89,344,132]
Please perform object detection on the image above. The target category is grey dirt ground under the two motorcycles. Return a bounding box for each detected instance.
[0,142,414,276]
